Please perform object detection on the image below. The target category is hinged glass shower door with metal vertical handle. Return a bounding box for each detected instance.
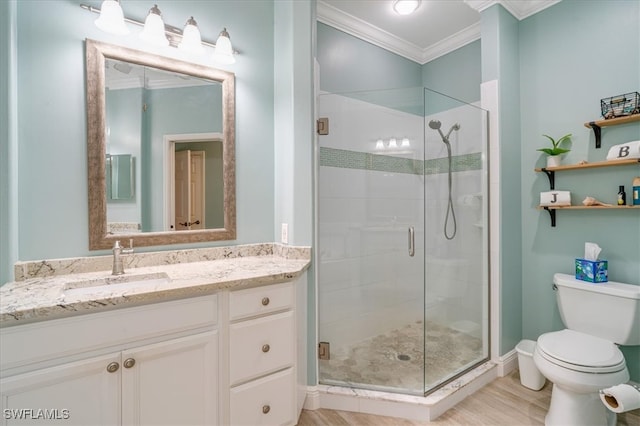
[318,88,425,395]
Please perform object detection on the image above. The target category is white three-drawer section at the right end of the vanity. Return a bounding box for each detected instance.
[229,280,306,426]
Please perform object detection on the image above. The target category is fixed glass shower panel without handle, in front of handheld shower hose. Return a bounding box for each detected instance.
[424,89,489,391]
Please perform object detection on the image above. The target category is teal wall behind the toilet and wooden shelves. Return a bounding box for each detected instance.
[520,0,640,381]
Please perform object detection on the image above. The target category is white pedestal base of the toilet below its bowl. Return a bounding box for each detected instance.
[544,384,617,426]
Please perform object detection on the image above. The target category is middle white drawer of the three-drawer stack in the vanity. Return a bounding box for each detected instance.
[229,311,295,385]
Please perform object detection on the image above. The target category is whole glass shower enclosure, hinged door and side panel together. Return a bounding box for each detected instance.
[318,88,489,395]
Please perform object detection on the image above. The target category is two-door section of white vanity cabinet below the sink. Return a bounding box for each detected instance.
[0,295,219,426]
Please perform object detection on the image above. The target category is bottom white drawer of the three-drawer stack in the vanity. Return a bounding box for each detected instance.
[231,368,295,426]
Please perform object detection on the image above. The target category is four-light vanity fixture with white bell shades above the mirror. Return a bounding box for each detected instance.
[80,0,238,65]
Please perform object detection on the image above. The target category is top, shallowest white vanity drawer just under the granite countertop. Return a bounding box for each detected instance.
[229,282,295,321]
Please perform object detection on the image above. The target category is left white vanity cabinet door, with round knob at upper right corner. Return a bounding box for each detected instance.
[0,354,121,426]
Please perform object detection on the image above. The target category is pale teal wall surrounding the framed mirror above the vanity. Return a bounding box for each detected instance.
[0,0,275,282]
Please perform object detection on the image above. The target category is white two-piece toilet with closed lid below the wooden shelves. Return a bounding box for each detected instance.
[533,274,640,426]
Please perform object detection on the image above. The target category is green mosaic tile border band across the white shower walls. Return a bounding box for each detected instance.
[320,147,482,175]
